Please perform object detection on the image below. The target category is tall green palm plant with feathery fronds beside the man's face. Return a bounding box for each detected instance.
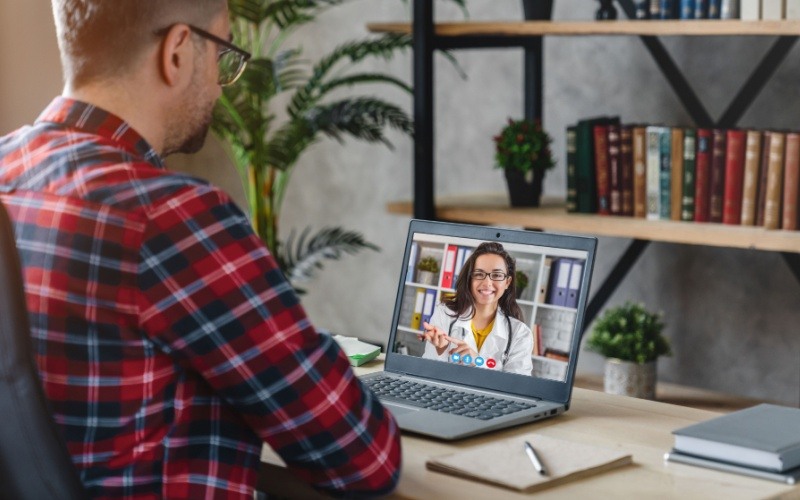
[212,0,428,288]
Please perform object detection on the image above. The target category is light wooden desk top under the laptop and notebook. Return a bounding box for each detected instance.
[265,362,800,500]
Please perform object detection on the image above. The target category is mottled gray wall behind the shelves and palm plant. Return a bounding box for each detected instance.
[0,0,800,405]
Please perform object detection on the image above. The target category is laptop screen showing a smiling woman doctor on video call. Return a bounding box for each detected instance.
[387,221,596,404]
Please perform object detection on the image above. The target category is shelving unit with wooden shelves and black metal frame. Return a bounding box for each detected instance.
[368,0,800,326]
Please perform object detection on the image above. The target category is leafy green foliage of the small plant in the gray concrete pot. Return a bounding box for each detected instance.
[586,302,672,363]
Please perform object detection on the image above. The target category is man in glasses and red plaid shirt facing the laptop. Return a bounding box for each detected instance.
[0,0,400,499]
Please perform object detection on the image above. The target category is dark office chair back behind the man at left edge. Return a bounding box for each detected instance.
[0,203,87,500]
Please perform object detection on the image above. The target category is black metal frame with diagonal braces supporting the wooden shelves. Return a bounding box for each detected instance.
[413,0,800,328]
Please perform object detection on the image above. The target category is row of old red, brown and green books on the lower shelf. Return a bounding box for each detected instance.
[567,117,800,230]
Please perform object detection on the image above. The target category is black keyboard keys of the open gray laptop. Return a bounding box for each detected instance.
[364,377,536,420]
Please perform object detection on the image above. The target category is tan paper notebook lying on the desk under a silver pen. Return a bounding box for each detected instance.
[425,434,633,493]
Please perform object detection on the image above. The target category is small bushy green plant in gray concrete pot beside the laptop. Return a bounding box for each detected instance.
[586,302,672,399]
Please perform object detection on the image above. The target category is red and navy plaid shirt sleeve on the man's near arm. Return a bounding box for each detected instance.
[139,186,400,493]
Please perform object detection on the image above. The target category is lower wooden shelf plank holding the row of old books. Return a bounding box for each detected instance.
[387,195,800,253]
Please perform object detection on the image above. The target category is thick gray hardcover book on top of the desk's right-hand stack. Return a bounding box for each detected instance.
[672,404,800,472]
